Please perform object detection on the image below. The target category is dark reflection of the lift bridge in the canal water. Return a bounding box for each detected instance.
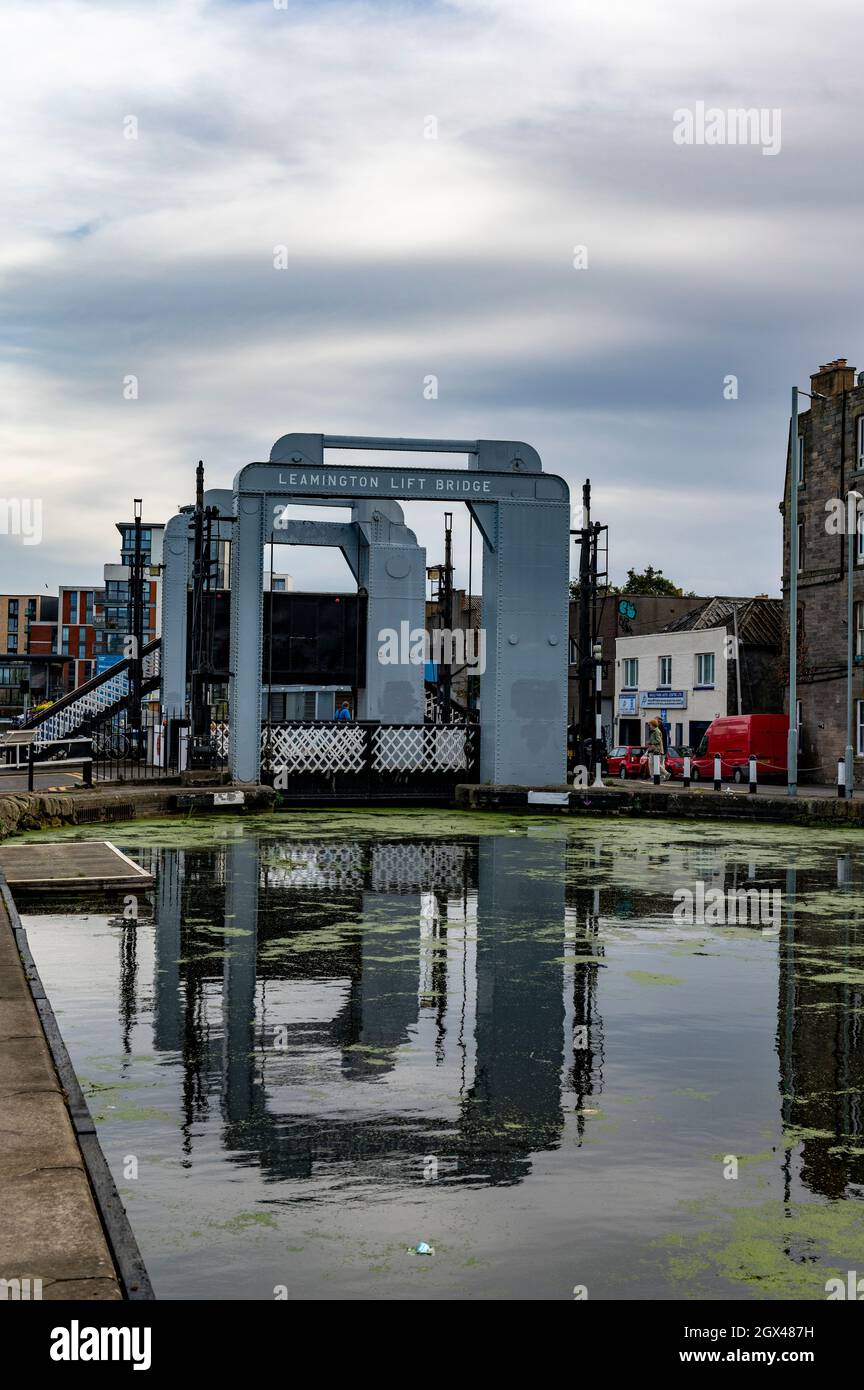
[148,837,601,1183]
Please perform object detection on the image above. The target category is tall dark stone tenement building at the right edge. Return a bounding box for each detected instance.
[781,357,864,785]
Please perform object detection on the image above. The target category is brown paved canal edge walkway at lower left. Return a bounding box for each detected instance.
[0,878,153,1301]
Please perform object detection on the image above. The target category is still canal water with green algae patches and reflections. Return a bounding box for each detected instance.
[24,810,864,1300]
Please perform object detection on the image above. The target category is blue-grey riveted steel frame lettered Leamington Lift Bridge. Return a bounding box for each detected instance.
[161,434,570,785]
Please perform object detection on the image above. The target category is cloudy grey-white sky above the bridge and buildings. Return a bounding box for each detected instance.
[0,0,864,594]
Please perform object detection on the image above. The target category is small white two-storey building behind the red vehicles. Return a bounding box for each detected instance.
[614,626,729,748]
